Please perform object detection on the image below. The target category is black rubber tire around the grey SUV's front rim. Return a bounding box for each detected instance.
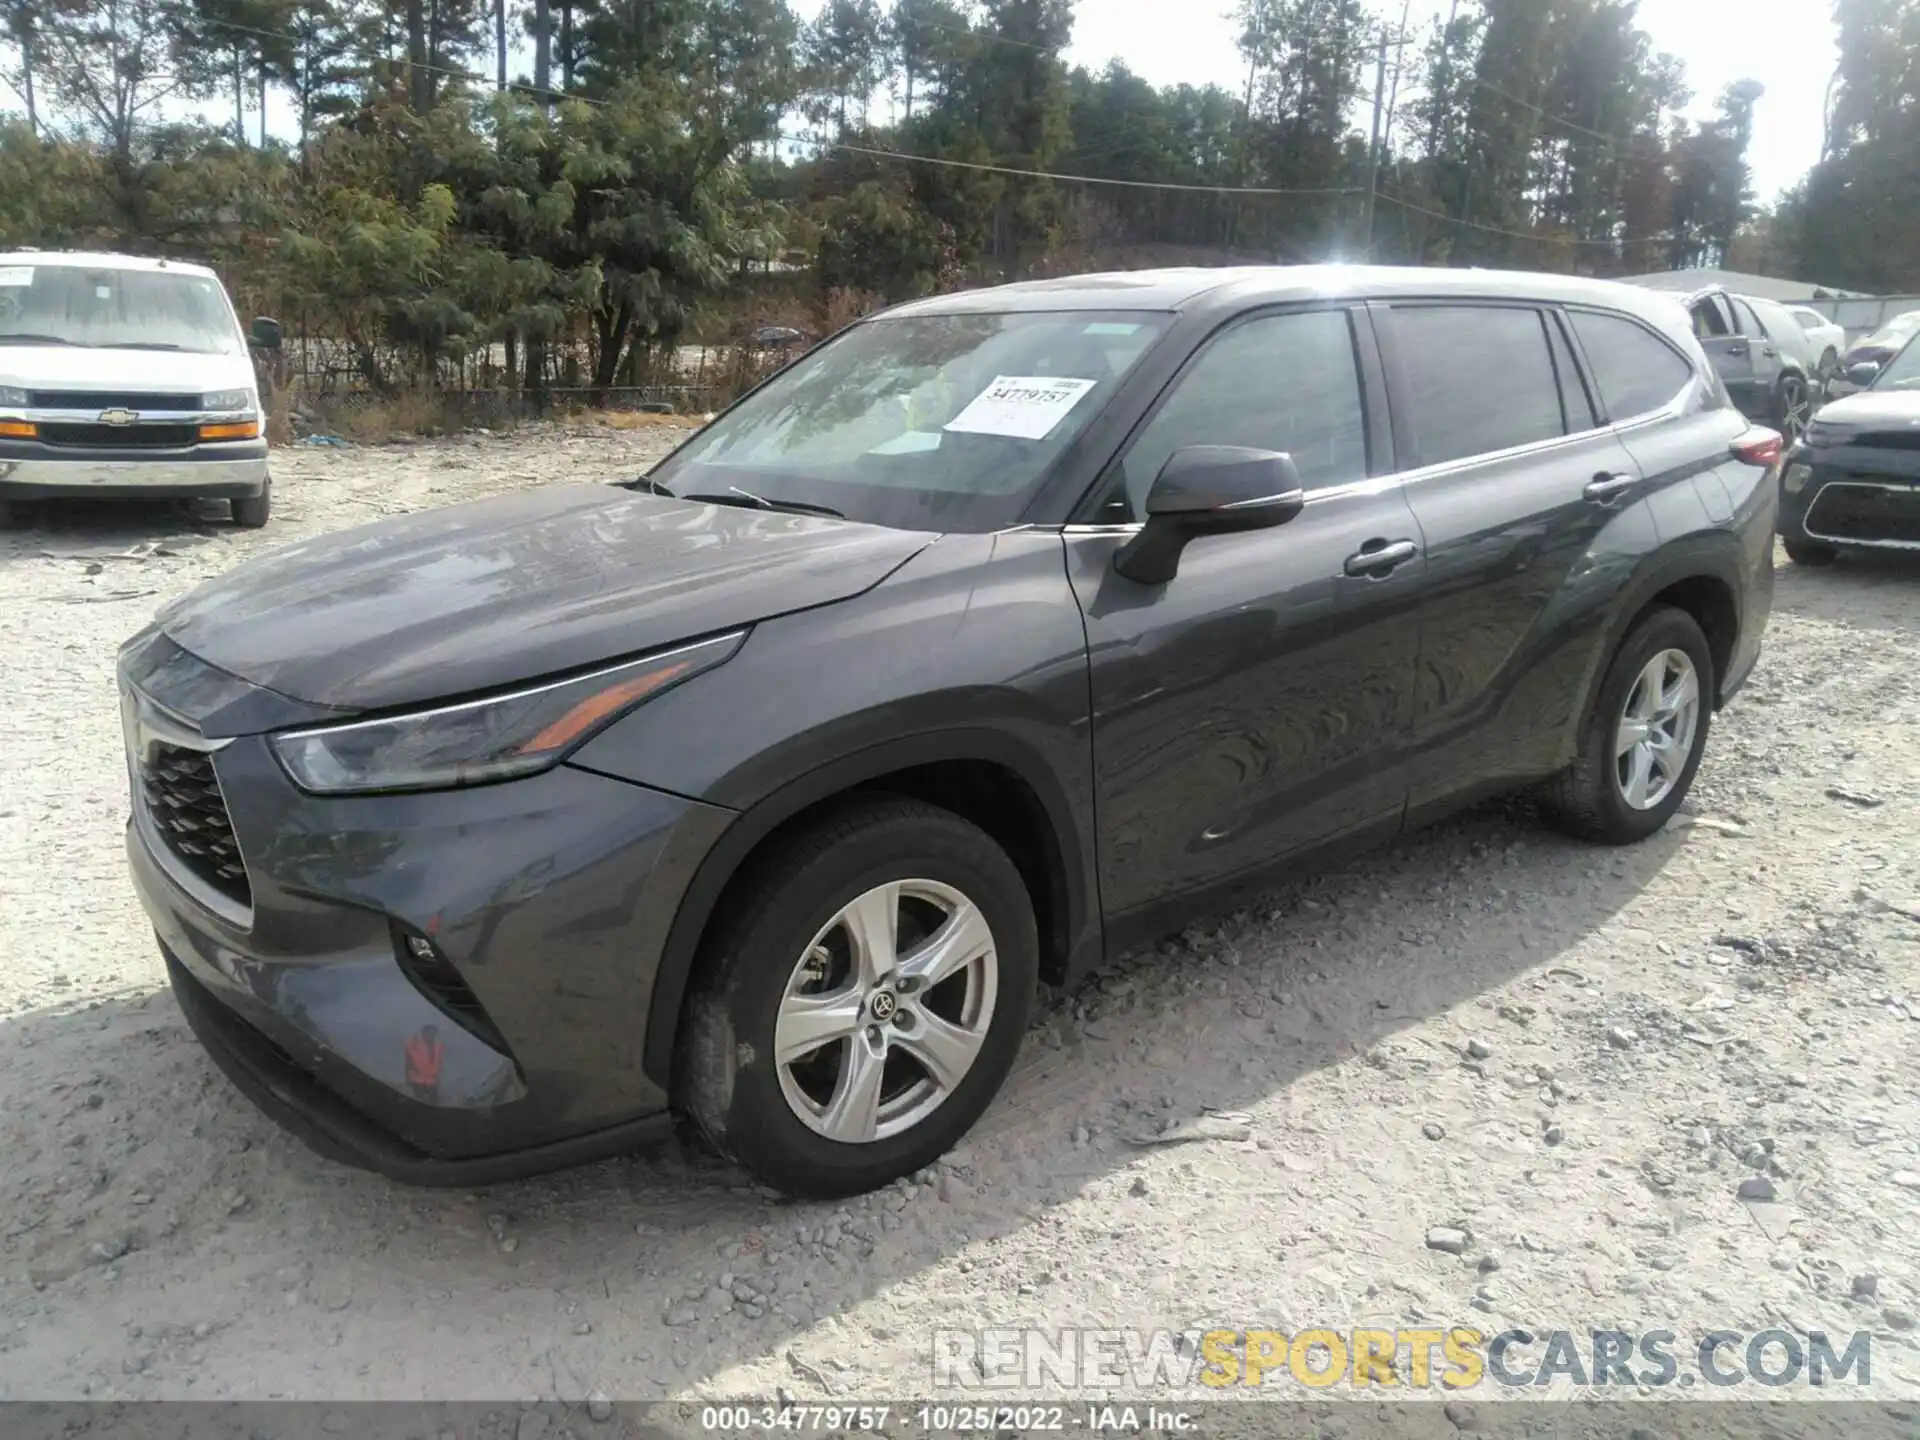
[674,797,1039,1198]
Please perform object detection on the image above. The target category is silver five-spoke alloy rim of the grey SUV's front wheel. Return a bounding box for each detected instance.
[774,879,998,1144]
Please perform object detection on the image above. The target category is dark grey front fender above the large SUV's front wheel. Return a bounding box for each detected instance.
[570,530,1098,1081]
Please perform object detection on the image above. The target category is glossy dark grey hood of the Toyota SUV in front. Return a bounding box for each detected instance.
[156,486,933,710]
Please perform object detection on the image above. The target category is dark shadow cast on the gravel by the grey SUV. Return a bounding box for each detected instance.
[0,803,1681,1400]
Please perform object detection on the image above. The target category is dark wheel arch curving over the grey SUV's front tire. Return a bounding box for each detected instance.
[641,730,1100,1087]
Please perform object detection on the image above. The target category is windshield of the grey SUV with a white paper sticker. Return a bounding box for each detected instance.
[651,311,1167,532]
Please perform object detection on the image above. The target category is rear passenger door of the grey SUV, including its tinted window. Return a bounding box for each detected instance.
[1380,300,1653,818]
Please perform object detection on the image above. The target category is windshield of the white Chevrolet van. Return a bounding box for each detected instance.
[0,263,244,355]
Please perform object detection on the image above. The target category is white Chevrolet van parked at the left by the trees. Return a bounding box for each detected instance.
[0,252,280,528]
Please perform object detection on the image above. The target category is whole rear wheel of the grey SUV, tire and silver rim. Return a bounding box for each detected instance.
[1546,607,1715,845]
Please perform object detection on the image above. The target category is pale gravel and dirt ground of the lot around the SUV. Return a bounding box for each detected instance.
[0,430,1920,1402]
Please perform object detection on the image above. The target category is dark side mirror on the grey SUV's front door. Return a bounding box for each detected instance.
[1114,445,1308,586]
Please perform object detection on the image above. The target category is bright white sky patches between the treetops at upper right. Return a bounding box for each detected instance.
[1059,0,1839,204]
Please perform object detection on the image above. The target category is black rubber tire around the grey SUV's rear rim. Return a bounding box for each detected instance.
[1546,605,1718,845]
